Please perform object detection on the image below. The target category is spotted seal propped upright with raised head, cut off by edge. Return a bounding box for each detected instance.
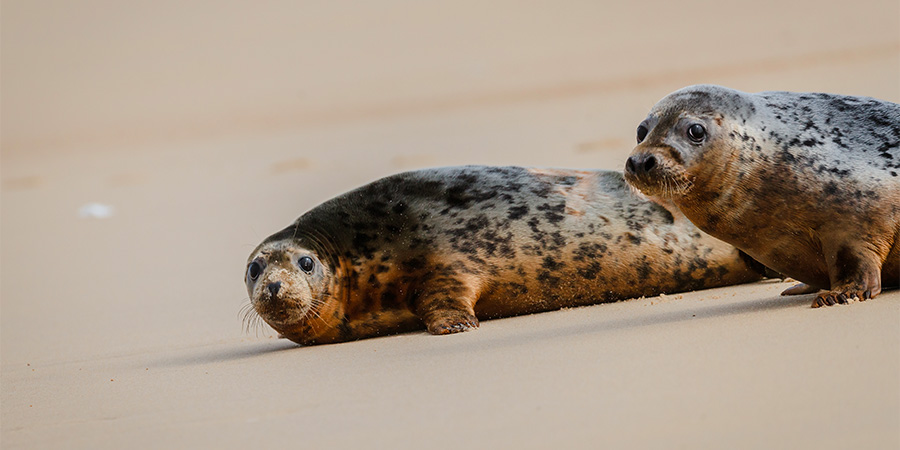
[625,86,900,307]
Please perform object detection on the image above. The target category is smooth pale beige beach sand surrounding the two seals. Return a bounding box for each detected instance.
[0,0,900,449]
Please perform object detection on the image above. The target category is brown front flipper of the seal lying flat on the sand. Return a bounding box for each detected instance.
[415,279,478,334]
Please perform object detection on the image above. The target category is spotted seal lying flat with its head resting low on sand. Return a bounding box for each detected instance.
[245,166,762,344]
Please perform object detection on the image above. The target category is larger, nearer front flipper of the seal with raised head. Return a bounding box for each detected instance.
[812,245,881,308]
